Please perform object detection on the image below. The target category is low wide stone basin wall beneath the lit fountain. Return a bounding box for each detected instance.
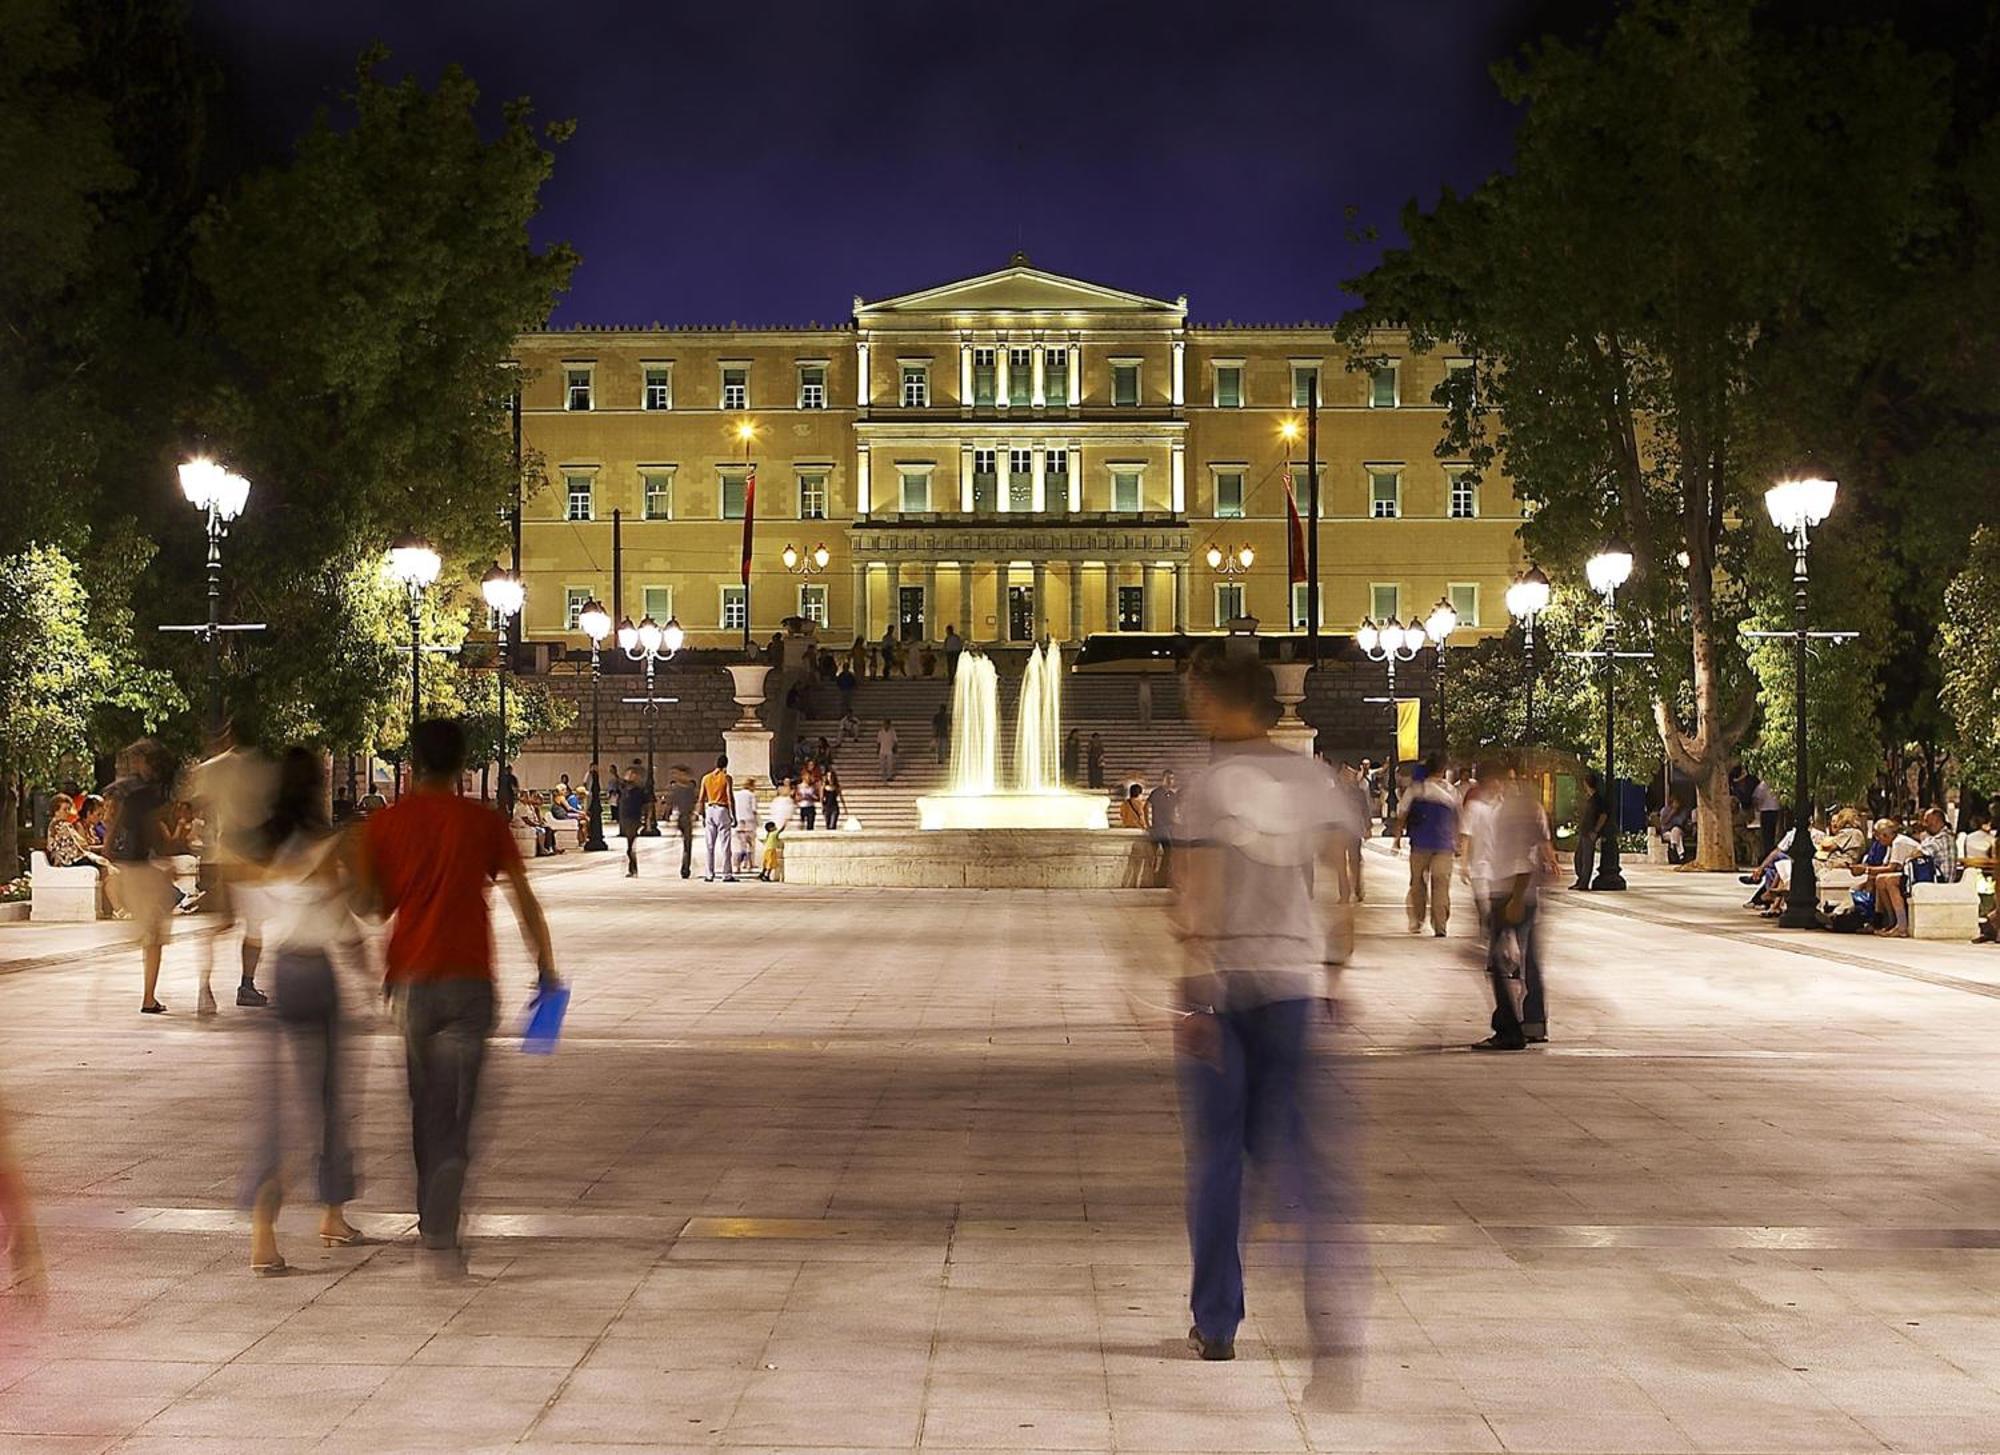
[784,827,1160,889]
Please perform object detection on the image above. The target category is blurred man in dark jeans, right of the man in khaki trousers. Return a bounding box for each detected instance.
[1472,765,1556,1051]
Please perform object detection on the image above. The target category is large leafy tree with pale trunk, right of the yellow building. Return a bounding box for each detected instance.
[1344,0,1944,867]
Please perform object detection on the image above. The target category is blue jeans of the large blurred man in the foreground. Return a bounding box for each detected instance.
[1178,999,1362,1353]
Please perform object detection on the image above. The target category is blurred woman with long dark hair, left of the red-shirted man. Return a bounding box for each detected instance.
[248,747,368,1275]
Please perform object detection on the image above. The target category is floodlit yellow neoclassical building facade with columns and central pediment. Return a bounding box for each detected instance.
[518,258,1520,646]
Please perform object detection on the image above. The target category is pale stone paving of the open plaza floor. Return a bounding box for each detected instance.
[0,841,2000,1455]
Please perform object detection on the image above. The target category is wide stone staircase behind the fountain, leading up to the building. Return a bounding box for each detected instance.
[800,672,1208,829]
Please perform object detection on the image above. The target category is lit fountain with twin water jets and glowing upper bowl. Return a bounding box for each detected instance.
[916,642,1104,829]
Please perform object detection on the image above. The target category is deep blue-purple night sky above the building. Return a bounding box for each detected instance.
[192,0,1560,324]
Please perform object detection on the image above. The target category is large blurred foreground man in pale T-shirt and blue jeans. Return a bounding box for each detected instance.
[1174,646,1364,1403]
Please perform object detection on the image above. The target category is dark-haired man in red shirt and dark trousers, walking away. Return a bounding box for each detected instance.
[358,720,558,1259]
